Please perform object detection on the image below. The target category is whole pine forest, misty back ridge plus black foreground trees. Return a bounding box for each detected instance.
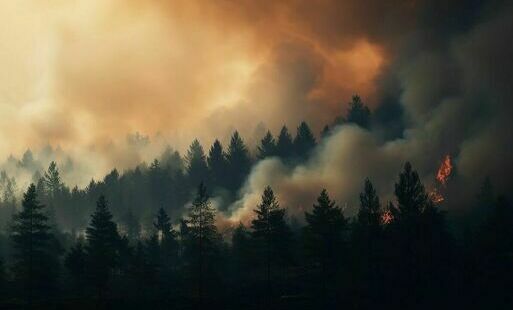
[0,96,513,309]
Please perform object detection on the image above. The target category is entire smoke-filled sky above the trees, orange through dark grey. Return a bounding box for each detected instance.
[0,0,513,213]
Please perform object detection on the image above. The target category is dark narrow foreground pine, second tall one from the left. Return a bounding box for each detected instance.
[86,195,120,300]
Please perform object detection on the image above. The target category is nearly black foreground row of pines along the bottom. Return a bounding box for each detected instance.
[0,163,513,308]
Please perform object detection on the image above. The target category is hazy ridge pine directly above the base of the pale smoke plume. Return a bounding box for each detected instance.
[226,131,251,191]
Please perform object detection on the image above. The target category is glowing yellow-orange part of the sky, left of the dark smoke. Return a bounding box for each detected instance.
[0,0,385,156]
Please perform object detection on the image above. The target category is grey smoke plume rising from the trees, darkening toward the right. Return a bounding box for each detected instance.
[226,3,513,221]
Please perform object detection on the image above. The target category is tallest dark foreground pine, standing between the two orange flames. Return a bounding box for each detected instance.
[384,163,450,308]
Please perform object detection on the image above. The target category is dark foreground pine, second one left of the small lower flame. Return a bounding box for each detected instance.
[305,189,347,293]
